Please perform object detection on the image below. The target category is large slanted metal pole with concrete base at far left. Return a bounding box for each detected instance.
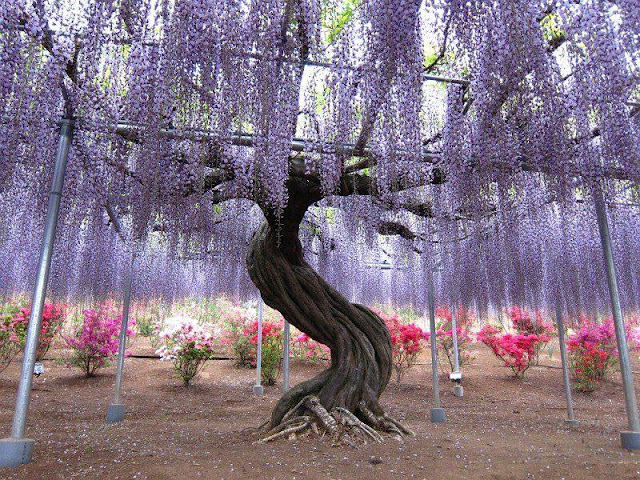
[0,119,73,467]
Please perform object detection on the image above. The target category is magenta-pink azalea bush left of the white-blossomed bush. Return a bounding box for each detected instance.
[65,301,136,377]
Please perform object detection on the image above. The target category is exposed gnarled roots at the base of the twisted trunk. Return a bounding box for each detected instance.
[258,395,414,448]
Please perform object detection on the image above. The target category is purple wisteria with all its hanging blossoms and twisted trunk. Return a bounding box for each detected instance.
[0,0,640,434]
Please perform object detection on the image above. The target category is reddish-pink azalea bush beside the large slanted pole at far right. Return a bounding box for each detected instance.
[567,317,639,392]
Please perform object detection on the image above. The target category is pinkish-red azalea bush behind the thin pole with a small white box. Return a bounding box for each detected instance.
[436,305,474,372]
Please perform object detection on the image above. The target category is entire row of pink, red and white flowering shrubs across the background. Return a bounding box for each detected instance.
[7,298,640,398]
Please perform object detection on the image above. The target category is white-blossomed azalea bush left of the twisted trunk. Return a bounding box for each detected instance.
[156,317,215,387]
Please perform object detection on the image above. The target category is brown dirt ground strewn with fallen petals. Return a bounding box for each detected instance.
[0,345,640,480]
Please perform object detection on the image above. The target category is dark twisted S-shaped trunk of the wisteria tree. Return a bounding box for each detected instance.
[247,177,407,442]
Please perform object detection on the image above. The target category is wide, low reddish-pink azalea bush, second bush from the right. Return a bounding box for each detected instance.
[477,324,550,378]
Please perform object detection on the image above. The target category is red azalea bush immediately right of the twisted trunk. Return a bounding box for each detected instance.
[376,312,429,384]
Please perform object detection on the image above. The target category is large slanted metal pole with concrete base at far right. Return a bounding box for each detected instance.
[593,188,640,450]
